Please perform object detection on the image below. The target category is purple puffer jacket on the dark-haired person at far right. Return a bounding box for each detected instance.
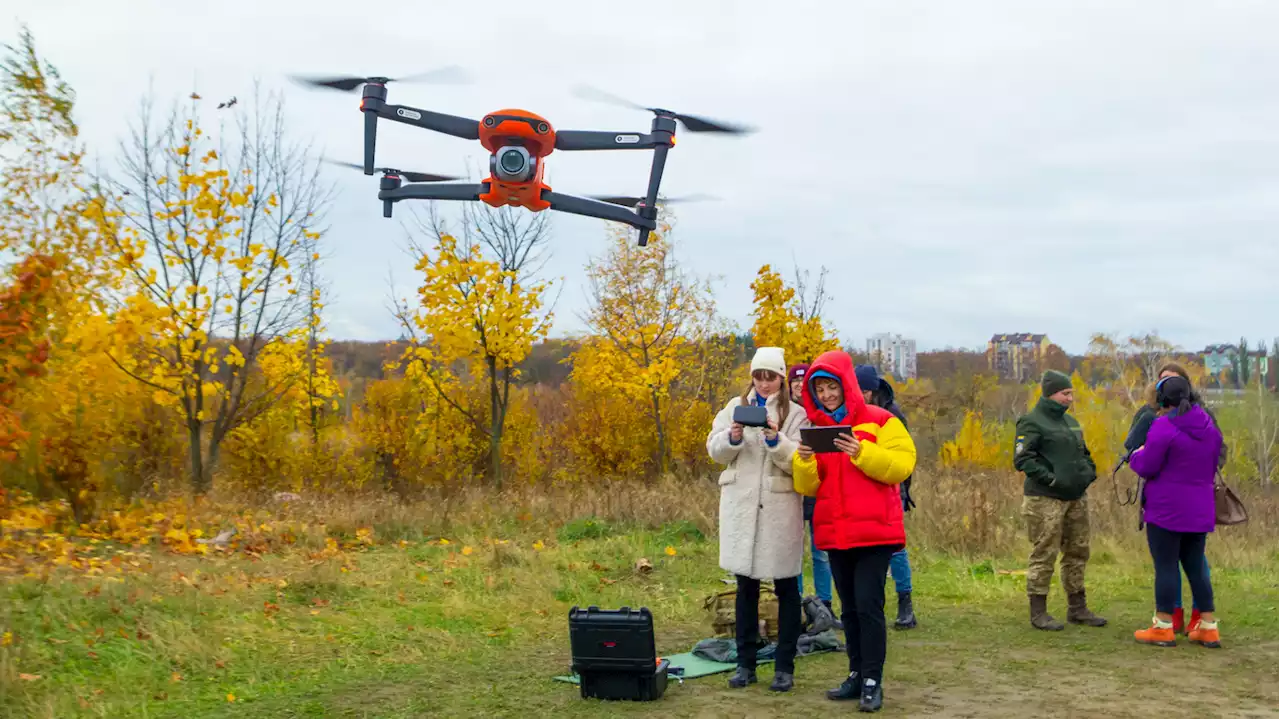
[1129,406,1222,532]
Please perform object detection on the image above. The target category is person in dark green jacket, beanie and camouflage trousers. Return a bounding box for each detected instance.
[1014,370,1107,631]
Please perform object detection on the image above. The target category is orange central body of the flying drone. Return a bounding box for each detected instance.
[480,109,556,212]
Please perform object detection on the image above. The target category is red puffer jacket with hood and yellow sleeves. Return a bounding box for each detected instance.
[791,351,915,550]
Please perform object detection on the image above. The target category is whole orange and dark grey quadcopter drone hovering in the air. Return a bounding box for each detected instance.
[294,68,751,247]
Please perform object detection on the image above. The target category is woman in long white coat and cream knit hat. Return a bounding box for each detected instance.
[707,347,805,692]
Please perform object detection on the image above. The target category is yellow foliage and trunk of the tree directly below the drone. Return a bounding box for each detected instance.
[397,234,552,486]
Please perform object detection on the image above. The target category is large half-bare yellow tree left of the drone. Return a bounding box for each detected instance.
[93,82,329,486]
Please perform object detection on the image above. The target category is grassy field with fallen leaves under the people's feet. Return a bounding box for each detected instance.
[0,498,1280,719]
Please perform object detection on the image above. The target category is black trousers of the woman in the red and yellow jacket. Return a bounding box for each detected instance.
[827,545,902,682]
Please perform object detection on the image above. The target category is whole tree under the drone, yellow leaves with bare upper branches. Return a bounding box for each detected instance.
[396,205,553,486]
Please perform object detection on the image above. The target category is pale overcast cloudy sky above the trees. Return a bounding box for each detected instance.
[0,0,1280,352]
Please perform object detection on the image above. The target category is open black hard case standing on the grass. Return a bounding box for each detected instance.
[568,606,668,701]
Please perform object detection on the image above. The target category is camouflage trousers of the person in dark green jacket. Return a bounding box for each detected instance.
[1023,496,1089,595]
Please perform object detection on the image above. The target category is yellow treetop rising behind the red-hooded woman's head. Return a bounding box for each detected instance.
[751,265,840,362]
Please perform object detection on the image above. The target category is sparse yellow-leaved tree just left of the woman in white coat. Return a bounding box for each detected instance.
[571,211,714,472]
